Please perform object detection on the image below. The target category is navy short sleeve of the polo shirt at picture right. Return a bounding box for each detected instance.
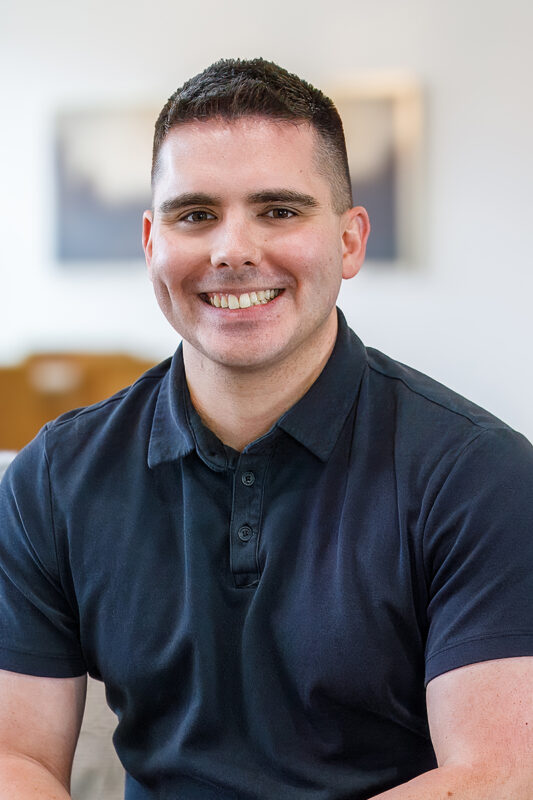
[424,428,533,683]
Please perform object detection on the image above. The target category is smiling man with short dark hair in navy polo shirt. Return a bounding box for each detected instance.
[0,60,533,800]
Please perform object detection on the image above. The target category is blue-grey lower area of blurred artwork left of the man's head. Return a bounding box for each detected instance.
[56,143,151,262]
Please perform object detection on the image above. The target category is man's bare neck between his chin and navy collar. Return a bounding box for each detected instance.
[183,313,337,451]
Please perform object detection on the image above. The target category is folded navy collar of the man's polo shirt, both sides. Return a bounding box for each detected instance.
[148,309,367,470]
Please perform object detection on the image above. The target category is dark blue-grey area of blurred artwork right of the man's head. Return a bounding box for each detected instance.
[352,154,399,261]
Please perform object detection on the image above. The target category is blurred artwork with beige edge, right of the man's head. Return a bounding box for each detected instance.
[330,75,423,267]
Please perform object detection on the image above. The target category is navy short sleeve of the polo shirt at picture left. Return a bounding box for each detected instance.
[0,428,86,678]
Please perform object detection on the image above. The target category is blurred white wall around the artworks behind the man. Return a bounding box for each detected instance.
[0,0,533,438]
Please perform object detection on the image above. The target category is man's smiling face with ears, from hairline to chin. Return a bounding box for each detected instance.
[143,117,368,370]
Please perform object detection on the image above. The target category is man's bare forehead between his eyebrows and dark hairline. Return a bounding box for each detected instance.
[154,117,329,202]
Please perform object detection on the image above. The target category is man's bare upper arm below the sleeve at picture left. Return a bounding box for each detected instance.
[0,670,87,787]
